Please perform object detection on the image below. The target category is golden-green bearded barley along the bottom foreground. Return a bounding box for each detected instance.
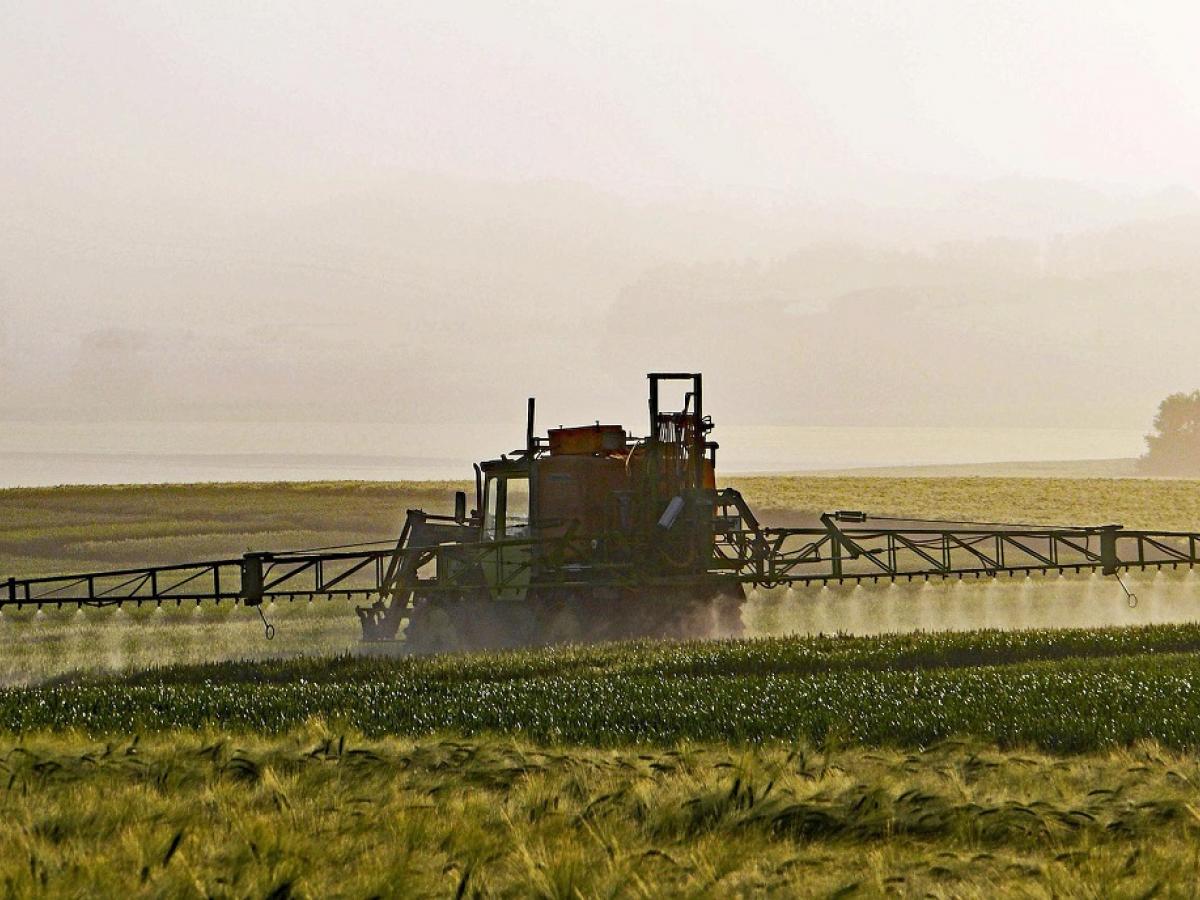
[7,721,1200,898]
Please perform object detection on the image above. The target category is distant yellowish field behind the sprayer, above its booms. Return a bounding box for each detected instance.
[0,476,1200,577]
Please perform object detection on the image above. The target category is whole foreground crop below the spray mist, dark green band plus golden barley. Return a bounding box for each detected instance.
[11,625,1200,898]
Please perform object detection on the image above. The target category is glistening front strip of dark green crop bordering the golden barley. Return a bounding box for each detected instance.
[7,654,1200,751]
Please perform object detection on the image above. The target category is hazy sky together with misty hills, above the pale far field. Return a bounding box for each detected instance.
[0,2,1200,428]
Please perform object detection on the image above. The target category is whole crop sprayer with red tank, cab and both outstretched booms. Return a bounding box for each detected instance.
[0,372,1200,652]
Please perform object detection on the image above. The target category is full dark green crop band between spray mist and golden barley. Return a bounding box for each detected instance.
[11,625,1200,752]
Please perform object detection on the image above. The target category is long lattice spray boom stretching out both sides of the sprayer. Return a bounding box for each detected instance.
[9,508,1200,610]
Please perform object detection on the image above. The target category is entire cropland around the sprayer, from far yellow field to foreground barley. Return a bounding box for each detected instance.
[0,478,1200,898]
